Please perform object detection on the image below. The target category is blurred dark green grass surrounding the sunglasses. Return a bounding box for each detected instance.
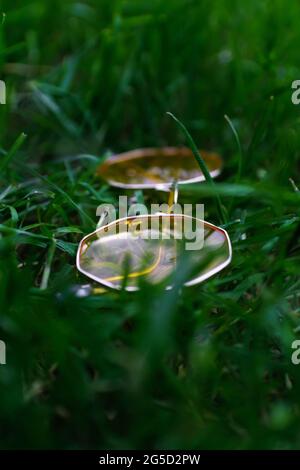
[0,0,300,449]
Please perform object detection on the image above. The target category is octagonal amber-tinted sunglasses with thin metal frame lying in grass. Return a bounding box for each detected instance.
[76,147,232,291]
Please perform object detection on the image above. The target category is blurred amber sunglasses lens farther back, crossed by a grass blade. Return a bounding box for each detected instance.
[97,147,222,190]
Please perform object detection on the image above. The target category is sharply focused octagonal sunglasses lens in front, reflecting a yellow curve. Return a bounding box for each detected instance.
[77,214,231,290]
